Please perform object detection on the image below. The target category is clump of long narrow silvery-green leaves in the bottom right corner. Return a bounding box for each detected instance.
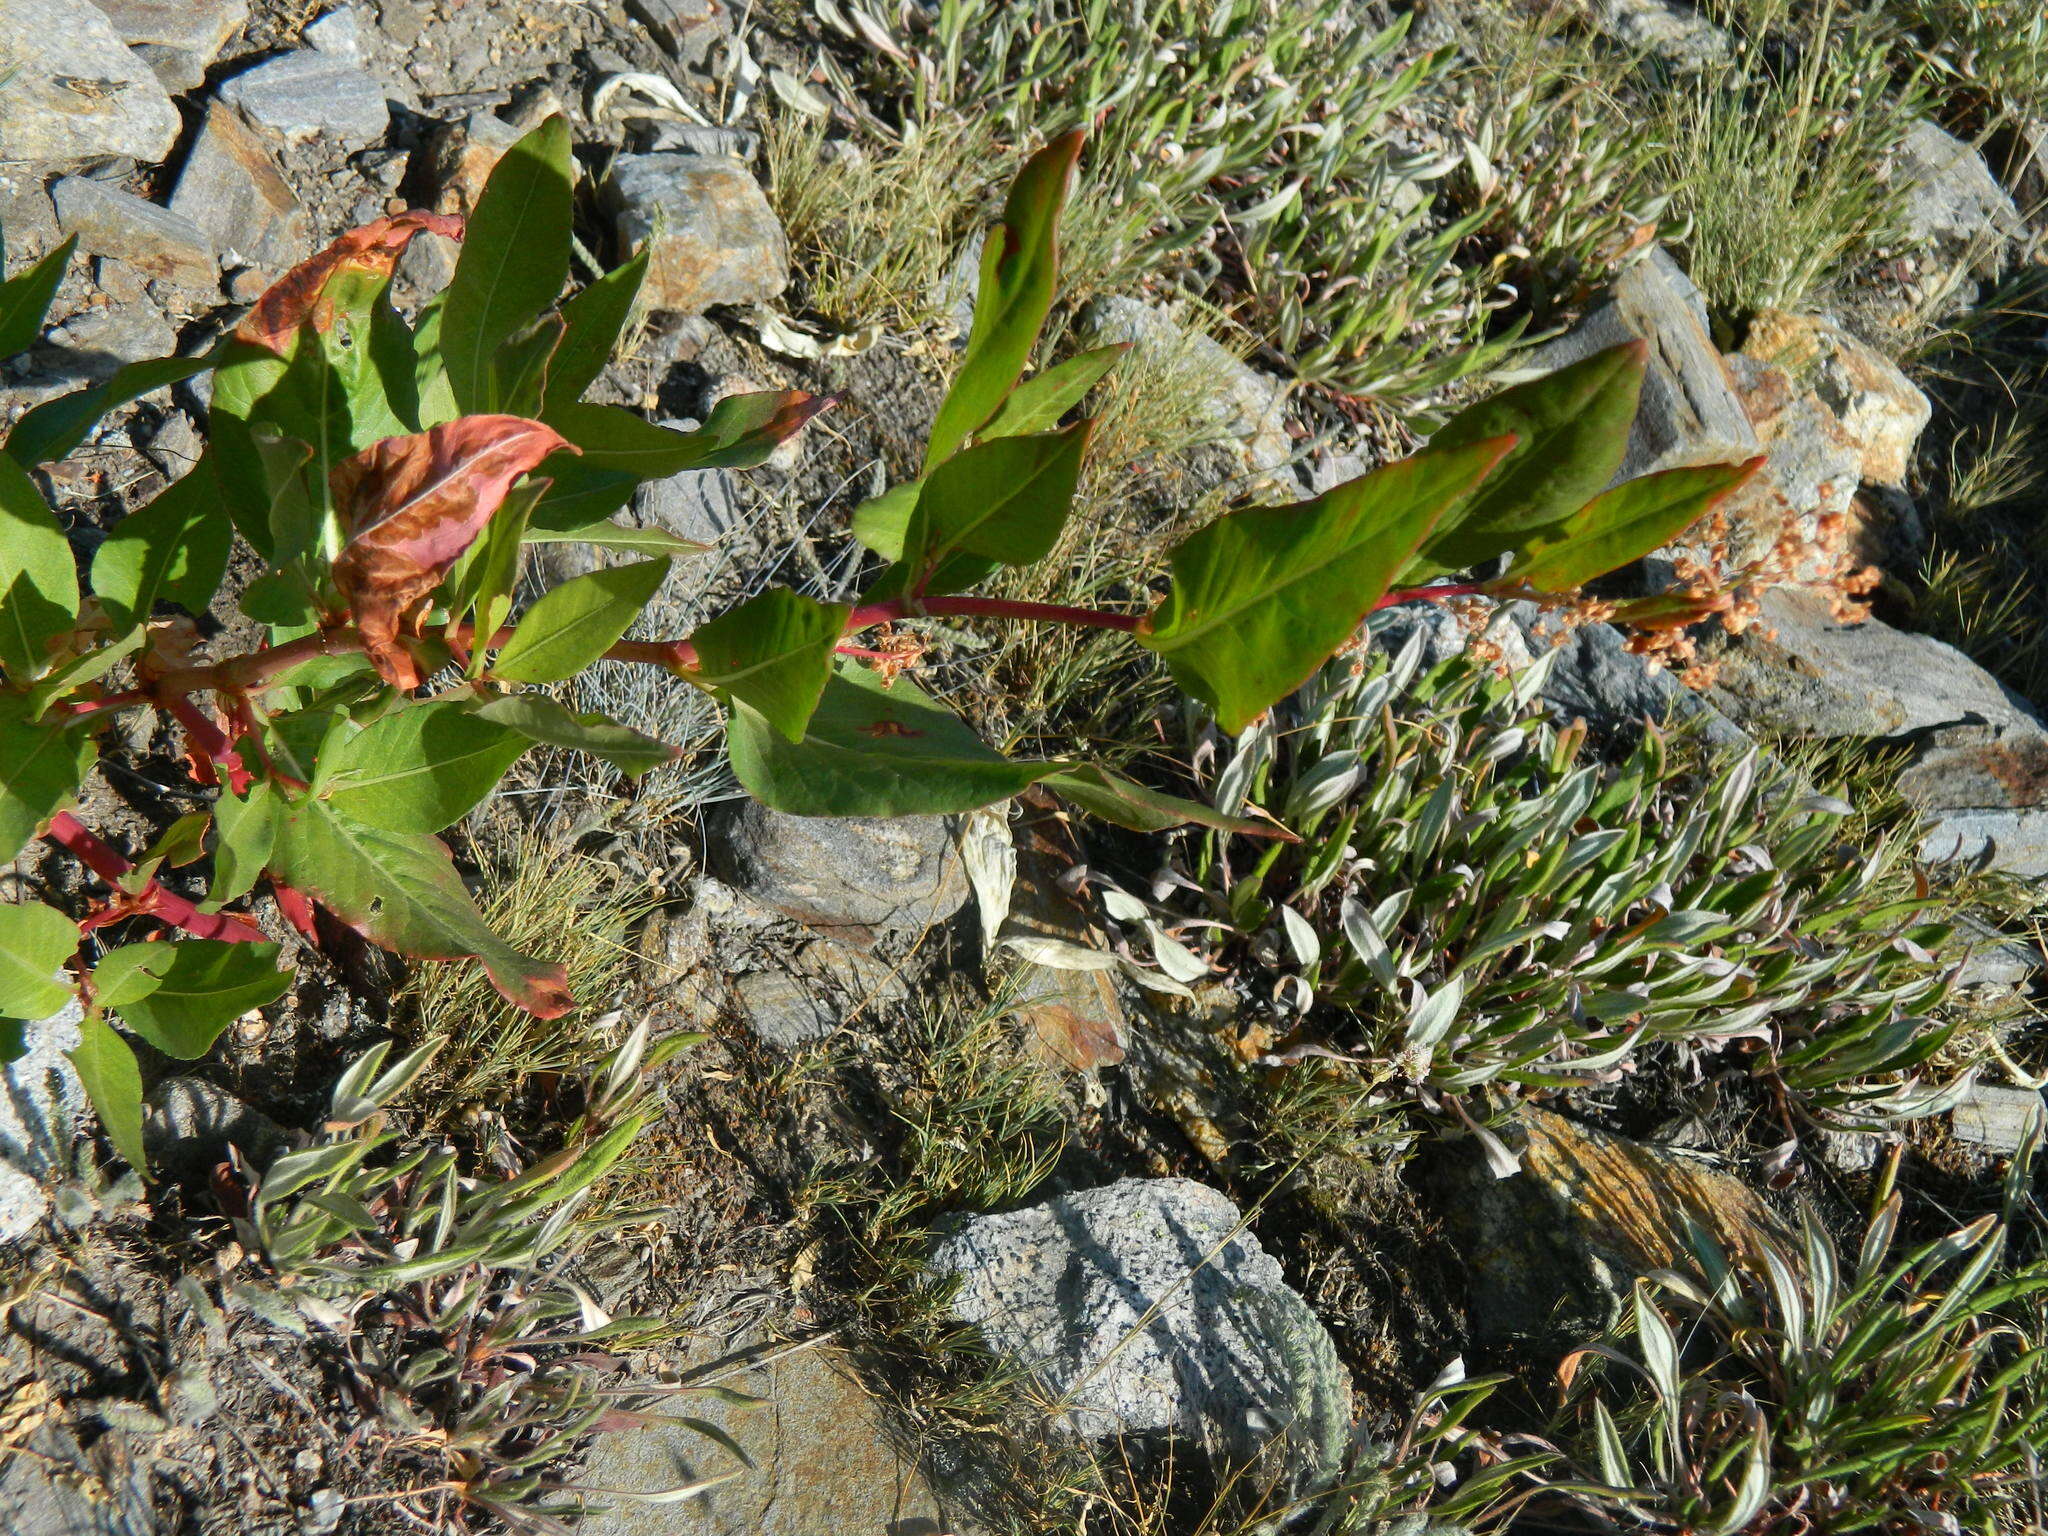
[1552,1128,2048,1536]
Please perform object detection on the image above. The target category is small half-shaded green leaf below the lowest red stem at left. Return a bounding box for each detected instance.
[92,938,291,1061]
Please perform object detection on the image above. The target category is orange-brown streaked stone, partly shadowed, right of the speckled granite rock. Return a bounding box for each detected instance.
[1446,1106,1798,1343]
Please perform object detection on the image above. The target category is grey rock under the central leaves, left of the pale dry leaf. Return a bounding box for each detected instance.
[709,801,971,948]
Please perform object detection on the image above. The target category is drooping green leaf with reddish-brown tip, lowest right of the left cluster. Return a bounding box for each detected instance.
[270,799,573,1018]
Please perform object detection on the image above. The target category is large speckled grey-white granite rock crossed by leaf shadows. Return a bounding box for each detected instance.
[932,1180,1352,1475]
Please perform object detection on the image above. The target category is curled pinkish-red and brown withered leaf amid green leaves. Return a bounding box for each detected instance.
[328,416,580,688]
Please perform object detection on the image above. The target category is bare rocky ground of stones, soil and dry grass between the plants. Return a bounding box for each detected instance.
[0,0,2048,1536]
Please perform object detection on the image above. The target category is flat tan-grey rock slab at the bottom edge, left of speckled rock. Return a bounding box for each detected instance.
[575,1348,952,1536]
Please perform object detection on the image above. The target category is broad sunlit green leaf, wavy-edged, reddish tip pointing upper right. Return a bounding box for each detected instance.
[1137,438,1513,735]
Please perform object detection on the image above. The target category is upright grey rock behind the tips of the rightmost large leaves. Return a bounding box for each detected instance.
[1528,250,1757,479]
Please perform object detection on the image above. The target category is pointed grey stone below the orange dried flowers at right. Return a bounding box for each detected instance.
[1708,588,2034,737]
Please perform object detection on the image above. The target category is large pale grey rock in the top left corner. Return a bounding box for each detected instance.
[0,0,178,164]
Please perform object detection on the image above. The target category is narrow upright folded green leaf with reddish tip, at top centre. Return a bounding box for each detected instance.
[924,131,1081,469]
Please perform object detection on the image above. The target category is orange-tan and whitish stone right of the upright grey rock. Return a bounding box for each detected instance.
[1743,309,1933,485]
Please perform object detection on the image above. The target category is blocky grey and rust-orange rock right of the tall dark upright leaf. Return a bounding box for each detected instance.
[606,154,788,315]
